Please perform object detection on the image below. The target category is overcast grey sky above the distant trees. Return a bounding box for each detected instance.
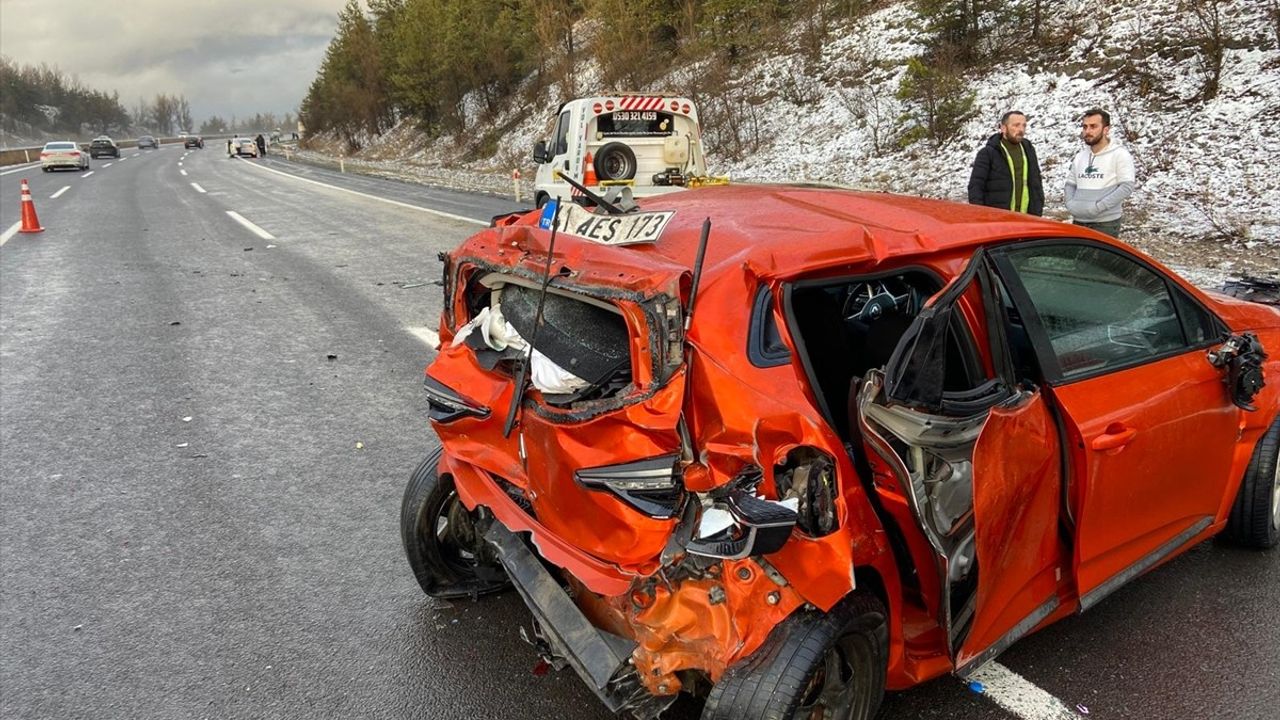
[0,0,346,126]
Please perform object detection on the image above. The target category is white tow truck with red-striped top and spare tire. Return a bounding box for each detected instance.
[534,94,727,208]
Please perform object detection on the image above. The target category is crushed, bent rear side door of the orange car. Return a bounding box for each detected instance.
[858,250,1066,675]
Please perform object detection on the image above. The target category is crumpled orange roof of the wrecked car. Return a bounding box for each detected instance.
[494,183,1107,291]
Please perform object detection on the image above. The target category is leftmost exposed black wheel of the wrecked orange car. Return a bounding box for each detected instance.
[401,448,511,598]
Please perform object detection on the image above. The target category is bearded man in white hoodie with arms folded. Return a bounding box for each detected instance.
[1066,108,1137,237]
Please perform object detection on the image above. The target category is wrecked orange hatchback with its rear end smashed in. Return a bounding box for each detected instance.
[402,186,1280,720]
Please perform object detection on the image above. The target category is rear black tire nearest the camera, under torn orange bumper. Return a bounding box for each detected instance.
[701,593,888,720]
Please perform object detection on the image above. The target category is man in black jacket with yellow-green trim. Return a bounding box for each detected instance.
[969,110,1044,215]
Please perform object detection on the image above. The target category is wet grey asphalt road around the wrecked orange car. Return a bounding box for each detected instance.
[0,146,1280,720]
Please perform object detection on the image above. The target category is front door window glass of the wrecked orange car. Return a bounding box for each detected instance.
[1007,243,1187,379]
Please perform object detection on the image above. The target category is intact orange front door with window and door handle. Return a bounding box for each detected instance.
[993,241,1240,611]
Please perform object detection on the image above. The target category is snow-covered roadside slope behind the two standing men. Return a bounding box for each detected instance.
[307,0,1280,284]
